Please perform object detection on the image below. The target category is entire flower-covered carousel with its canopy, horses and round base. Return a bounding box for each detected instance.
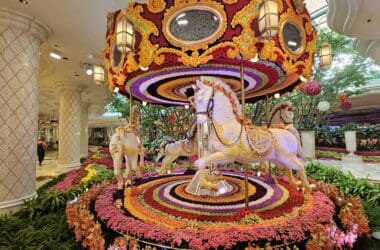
[95,0,334,249]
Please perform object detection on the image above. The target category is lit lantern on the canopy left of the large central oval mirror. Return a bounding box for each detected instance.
[116,17,135,53]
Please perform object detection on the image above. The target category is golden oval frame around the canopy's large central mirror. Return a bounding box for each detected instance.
[162,1,227,51]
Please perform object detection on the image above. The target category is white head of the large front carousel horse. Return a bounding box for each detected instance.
[194,80,214,124]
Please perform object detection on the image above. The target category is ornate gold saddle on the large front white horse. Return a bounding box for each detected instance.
[245,126,273,155]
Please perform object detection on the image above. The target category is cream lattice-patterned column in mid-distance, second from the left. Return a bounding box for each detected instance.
[58,83,81,167]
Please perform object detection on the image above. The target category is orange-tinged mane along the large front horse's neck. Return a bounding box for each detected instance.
[201,78,244,123]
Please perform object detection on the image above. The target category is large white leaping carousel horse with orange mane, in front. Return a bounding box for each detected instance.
[194,76,310,190]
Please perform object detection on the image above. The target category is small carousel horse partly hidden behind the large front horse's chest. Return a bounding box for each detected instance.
[156,121,198,175]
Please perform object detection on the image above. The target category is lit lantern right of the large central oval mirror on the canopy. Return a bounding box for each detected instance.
[259,0,278,39]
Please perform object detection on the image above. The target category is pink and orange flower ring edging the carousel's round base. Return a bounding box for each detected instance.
[95,171,335,249]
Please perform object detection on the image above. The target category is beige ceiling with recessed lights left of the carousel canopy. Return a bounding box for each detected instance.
[0,0,147,120]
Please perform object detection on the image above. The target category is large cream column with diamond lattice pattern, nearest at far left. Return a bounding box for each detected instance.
[0,8,51,214]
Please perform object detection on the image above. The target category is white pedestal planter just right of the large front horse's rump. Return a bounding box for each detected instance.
[298,118,316,158]
